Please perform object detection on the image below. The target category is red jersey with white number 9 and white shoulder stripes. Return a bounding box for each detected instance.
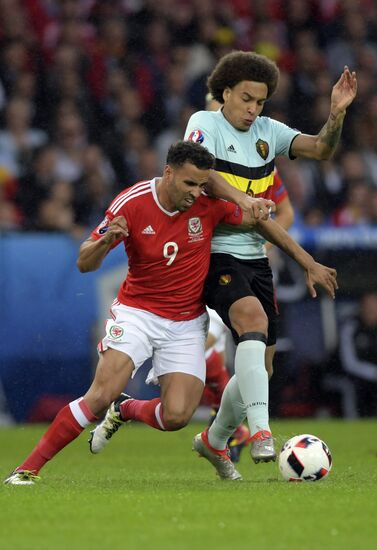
[92,179,242,320]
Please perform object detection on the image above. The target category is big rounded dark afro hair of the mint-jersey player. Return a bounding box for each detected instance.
[207,51,279,103]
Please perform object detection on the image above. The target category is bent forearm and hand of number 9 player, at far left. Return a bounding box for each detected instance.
[77,216,128,273]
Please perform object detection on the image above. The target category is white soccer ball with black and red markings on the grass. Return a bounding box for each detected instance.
[279,434,332,481]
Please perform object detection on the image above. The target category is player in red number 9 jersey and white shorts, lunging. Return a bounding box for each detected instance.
[4,141,337,485]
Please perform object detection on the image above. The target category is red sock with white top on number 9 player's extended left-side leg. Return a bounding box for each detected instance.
[17,399,97,474]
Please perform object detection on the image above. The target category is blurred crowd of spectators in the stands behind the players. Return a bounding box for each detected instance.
[0,0,377,238]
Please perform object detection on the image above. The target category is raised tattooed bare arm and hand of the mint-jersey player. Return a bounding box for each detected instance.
[291,66,357,160]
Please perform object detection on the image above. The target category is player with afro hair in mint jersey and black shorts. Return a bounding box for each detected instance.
[185,51,357,476]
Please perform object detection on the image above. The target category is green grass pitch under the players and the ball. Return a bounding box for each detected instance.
[0,420,377,550]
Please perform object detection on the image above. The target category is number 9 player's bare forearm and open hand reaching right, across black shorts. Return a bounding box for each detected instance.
[255,219,338,298]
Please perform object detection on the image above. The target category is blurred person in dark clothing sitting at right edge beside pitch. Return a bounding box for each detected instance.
[339,291,377,416]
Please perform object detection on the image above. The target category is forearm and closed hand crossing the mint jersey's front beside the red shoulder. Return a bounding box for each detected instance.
[206,170,275,220]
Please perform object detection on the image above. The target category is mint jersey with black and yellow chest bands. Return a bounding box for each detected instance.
[184,109,299,260]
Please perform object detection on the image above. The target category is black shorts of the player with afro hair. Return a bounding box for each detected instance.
[204,254,278,346]
